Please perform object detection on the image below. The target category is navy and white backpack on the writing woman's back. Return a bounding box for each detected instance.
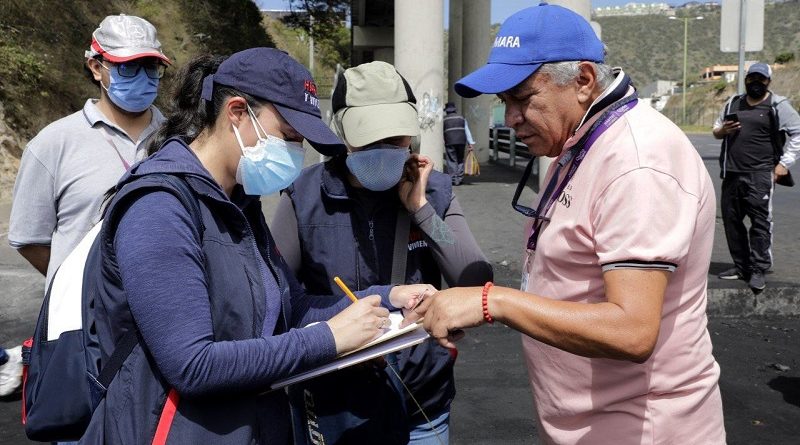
[22,175,202,442]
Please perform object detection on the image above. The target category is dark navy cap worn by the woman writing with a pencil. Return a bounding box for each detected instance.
[201,48,347,156]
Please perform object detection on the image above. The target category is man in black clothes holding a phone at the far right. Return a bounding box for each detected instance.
[712,63,800,291]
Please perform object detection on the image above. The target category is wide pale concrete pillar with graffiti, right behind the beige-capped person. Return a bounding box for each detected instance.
[394,0,446,170]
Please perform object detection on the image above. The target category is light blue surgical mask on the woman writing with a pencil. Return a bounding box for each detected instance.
[233,107,305,196]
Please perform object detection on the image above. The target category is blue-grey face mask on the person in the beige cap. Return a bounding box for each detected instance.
[345,145,409,192]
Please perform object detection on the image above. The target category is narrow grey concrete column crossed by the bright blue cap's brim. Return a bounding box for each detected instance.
[460,0,494,162]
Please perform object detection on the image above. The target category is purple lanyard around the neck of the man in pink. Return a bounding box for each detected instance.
[528,95,638,250]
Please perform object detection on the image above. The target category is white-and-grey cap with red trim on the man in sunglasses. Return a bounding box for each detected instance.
[85,14,172,64]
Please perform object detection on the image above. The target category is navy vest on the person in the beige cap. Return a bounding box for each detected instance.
[286,157,455,443]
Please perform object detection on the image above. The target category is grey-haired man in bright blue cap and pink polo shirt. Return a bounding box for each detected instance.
[409,3,725,444]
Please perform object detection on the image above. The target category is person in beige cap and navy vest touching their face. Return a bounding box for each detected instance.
[271,62,492,445]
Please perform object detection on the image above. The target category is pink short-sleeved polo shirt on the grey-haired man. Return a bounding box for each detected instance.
[523,95,725,445]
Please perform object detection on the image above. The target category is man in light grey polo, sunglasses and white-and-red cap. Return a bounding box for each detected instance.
[0,14,170,396]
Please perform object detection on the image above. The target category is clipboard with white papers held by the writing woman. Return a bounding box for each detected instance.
[270,312,429,390]
